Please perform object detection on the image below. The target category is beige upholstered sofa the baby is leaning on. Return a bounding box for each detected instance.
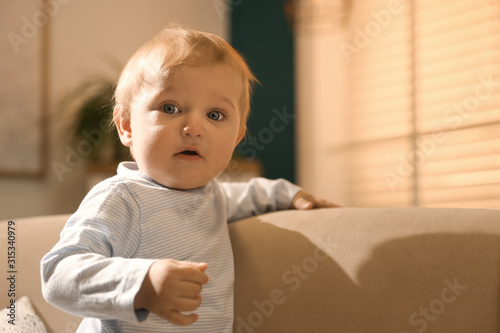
[0,208,500,333]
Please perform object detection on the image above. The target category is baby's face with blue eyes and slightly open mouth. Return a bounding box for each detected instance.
[123,64,245,189]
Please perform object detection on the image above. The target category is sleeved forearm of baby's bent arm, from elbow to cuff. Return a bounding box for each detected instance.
[41,251,153,322]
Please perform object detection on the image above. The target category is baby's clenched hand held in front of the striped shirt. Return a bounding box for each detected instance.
[134,259,208,325]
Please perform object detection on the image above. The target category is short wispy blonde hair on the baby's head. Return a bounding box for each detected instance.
[114,26,257,124]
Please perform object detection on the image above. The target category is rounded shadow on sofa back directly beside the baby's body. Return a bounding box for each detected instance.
[231,220,361,333]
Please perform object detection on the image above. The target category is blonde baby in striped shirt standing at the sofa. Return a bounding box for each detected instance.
[41,27,336,333]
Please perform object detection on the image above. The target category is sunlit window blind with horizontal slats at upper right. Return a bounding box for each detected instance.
[344,0,500,208]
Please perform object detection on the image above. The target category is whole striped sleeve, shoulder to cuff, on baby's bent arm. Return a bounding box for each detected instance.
[41,179,154,322]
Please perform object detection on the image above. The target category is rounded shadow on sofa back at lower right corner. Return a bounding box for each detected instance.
[351,233,500,333]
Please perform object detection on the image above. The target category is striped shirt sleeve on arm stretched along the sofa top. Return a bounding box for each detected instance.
[220,177,301,222]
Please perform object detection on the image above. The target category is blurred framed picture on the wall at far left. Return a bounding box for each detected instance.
[0,1,51,177]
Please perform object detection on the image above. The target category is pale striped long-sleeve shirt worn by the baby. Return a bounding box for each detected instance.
[41,162,300,333]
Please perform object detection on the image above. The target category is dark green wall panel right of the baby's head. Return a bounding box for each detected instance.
[229,0,295,182]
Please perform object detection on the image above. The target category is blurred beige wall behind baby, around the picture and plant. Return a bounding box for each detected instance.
[0,0,229,219]
